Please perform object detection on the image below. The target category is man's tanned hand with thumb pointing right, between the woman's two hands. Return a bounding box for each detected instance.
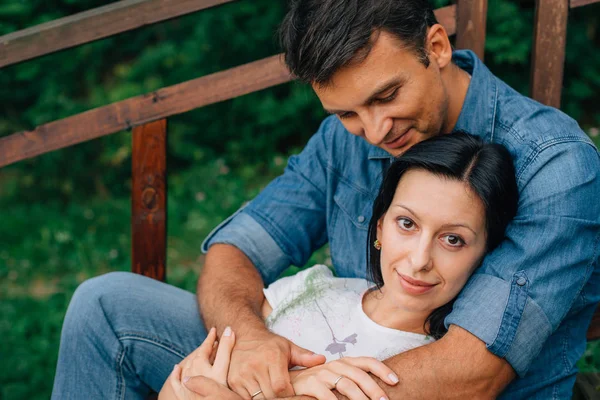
[227,329,325,399]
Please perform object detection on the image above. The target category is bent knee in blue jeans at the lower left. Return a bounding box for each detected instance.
[52,272,206,400]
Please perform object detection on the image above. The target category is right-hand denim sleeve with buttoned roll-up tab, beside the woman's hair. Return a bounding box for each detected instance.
[446,140,600,377]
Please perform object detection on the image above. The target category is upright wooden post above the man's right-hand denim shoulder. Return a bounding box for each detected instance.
[531,0,569,108]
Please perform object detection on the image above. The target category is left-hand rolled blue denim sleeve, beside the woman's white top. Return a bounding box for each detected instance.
[202,118,335,284]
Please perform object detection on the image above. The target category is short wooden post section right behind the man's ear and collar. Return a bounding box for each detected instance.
[456,0,487,60]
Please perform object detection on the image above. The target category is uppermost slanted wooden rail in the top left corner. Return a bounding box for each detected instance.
[0,0,236,68]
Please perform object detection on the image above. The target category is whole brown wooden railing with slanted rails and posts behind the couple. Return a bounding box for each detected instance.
[0,0,600,339]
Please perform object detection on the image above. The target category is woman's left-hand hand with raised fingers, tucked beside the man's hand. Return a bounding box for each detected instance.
[159,328,241,400]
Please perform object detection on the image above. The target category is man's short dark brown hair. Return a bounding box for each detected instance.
[279,0,437,85]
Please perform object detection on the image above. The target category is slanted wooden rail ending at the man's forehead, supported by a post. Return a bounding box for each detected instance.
[0,55,291,167]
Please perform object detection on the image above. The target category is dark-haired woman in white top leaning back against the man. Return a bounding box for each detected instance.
[161,133,518,399]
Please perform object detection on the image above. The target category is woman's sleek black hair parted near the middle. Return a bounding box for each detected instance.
[367,133,519,339]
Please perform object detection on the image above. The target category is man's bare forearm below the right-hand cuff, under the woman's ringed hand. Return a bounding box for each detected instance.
[336,325,515,400]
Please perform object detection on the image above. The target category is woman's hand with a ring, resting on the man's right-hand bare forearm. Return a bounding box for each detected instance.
[290,357,398,400]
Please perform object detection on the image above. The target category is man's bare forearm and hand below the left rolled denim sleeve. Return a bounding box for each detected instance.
[197,244,325,398]
